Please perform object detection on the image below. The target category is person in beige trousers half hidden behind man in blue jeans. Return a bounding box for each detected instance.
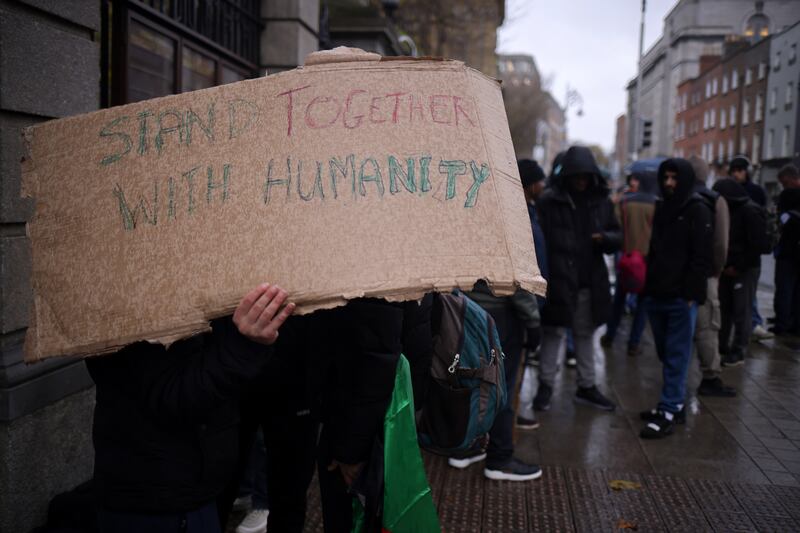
[689,156,736,397]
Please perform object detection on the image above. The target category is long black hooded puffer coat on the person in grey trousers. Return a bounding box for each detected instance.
[536,146,622,327]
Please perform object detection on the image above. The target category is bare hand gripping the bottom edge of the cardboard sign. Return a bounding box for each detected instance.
[233,283,295,346]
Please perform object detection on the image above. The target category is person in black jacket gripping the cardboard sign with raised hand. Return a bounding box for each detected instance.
[86,284,294,533]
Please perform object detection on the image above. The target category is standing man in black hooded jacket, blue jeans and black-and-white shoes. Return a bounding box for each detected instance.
[640,158,713,439]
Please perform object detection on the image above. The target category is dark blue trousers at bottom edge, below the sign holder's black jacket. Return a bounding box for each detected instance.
[97,502,222,533]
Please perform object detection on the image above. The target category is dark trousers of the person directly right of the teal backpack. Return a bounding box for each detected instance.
[486,306,523,468]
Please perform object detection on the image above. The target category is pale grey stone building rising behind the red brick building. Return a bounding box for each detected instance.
[627,0,800,162]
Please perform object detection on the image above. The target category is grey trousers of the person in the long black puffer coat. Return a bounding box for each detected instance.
[539,289,595,388]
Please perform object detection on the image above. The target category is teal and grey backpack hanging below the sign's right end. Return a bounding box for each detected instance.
[417,291,507,455]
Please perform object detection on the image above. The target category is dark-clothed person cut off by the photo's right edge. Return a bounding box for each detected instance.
[771,165,800,335]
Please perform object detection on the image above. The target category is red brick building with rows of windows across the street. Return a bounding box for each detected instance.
[673,37,770,175]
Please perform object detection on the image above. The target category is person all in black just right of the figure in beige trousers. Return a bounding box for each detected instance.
[714,179,767,366]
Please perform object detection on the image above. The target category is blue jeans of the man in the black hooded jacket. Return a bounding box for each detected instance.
[645,298,697,414]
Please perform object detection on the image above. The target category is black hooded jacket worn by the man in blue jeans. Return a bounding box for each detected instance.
[645,159,713,304]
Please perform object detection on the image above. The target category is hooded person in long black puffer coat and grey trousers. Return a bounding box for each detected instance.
[533,146,620,410]
